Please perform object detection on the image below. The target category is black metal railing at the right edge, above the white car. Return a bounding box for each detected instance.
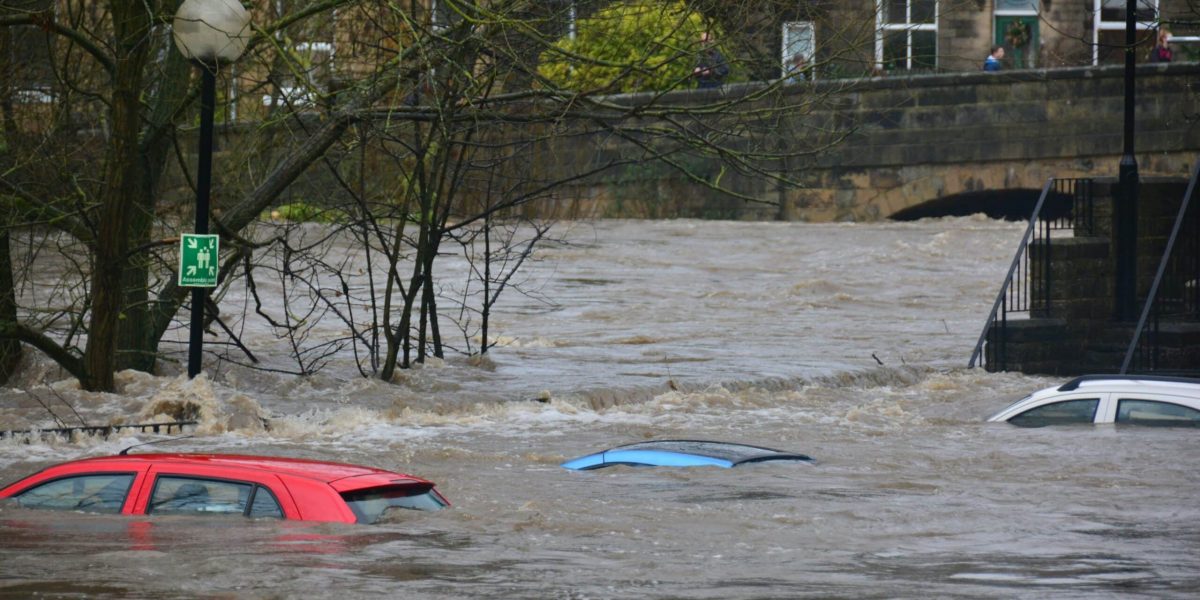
[1121,162,1200,374]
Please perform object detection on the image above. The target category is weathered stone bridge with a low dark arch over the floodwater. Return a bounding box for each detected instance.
[557,62,1200,221]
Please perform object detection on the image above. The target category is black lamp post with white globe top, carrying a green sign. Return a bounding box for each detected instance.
[172,0,250,378]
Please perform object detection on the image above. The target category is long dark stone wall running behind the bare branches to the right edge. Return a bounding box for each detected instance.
[182,64,1200,222]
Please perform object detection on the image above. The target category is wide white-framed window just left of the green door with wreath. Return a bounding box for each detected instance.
[875,0,937,71]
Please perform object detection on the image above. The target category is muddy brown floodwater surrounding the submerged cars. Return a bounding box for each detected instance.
[0,217,1200,599]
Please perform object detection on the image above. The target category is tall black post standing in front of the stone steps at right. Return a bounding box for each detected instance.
[1114,0,1139,320]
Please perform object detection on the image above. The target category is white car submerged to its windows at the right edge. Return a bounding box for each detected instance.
[988,376,1200,427]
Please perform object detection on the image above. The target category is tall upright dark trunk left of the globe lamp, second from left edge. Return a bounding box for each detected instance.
[80,0,151,391]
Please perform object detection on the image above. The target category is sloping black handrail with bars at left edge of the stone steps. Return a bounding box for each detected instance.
[967,178,1096,368]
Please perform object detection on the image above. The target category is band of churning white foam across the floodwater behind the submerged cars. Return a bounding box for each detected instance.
[6,360,1027,451]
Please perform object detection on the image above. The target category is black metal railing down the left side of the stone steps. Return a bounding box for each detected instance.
[967,178,1096,371]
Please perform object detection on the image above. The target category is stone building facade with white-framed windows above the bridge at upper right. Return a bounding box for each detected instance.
[780,0,1200,74]
